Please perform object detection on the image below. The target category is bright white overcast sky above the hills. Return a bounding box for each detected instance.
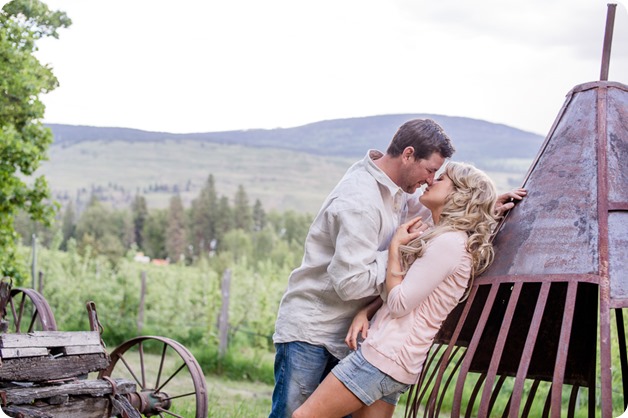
[5,0,628,135]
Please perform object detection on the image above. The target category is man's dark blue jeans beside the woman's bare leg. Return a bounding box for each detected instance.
[269,341,338,418]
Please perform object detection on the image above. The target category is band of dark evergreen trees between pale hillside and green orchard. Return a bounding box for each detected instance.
[15,174,312,264]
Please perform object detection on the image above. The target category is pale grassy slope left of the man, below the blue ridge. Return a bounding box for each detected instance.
[40,140,353,213]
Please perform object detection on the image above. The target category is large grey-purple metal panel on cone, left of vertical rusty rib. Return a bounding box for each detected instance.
[483,89,598,277]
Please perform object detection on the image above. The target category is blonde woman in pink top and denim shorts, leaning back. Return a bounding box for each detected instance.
[292,163,497,418]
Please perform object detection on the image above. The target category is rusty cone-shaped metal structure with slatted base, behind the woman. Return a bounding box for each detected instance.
[409,81,628,418]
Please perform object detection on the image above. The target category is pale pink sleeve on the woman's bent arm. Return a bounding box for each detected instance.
[386,233,466,318]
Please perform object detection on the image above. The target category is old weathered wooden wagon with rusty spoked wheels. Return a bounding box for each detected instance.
[0,280,208,418]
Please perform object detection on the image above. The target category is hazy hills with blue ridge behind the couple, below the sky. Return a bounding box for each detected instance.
[40,115,542,213]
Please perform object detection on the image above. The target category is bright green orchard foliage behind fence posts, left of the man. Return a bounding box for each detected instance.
[22,225,302,350]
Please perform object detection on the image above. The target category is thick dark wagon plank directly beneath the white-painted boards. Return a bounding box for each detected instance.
[0,354,110,382]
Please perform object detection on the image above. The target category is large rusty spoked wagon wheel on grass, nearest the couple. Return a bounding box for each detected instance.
[98,336,208,418]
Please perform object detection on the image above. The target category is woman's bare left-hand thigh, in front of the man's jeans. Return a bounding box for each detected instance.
[292,373,364,418]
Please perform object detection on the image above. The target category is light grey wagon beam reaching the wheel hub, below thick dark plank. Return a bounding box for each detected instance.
[2,379,137,405]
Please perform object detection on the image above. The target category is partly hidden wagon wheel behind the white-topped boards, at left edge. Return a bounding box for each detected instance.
[3,287,57,333]
